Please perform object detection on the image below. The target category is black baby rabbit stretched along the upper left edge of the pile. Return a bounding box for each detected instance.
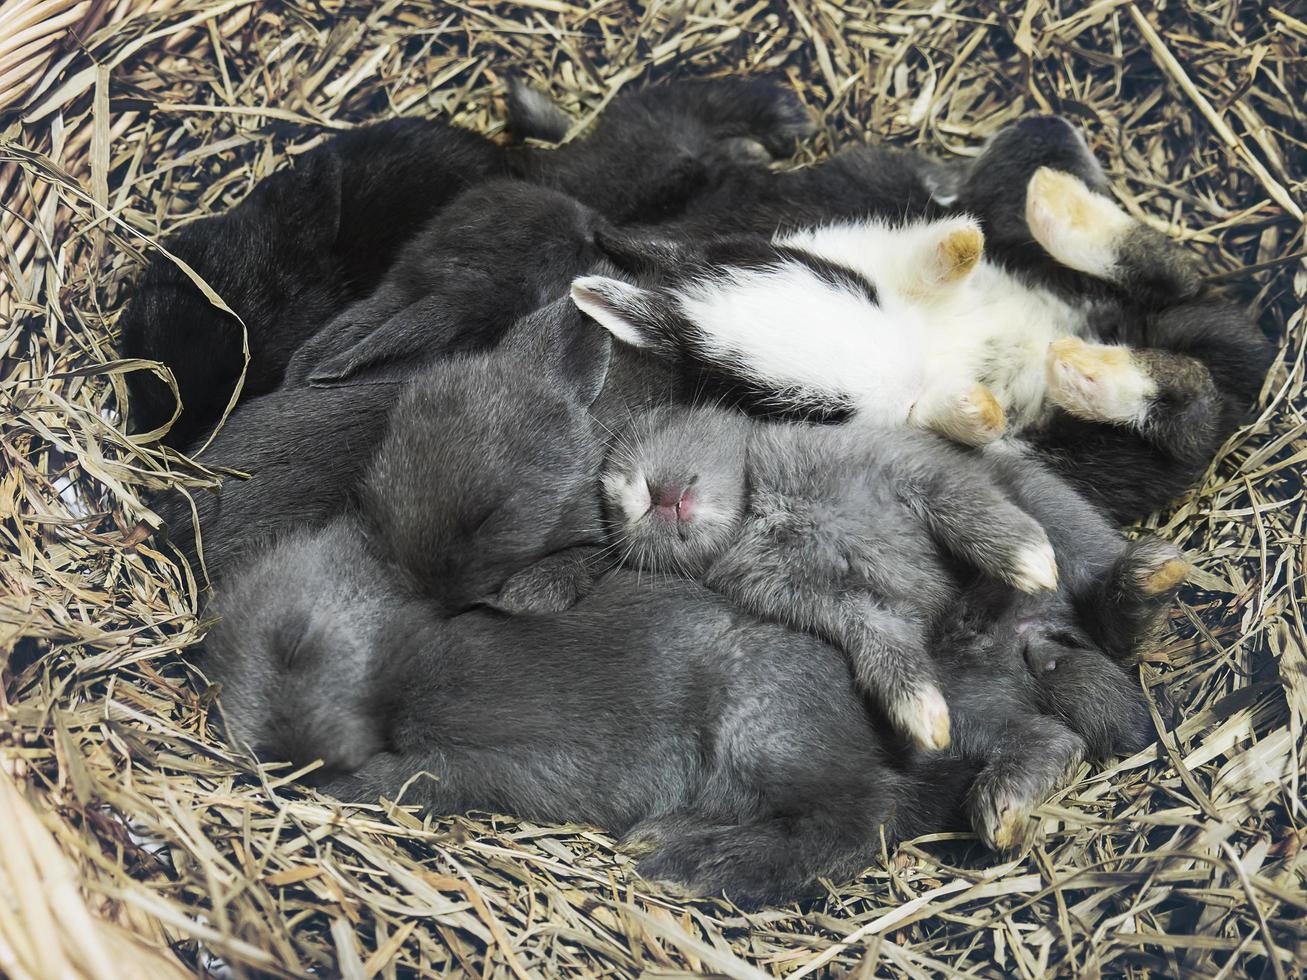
[120,80,812,447]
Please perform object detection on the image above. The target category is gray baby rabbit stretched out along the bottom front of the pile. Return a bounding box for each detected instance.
[204,533,972,908]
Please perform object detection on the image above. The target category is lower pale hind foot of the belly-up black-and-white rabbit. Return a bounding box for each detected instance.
[1047,337,1157,423]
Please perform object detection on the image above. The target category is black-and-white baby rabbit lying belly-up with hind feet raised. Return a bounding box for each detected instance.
[574,119,1270,520]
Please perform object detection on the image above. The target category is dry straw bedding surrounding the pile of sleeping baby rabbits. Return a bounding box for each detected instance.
[0,0,1307,977]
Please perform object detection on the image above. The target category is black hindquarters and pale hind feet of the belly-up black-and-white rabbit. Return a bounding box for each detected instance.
[954,116,1274,521]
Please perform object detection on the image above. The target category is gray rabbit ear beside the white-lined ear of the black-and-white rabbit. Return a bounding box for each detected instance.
[503,299,613,408]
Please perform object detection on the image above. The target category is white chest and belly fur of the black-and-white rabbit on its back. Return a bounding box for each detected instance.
[705,217,1087,439]
